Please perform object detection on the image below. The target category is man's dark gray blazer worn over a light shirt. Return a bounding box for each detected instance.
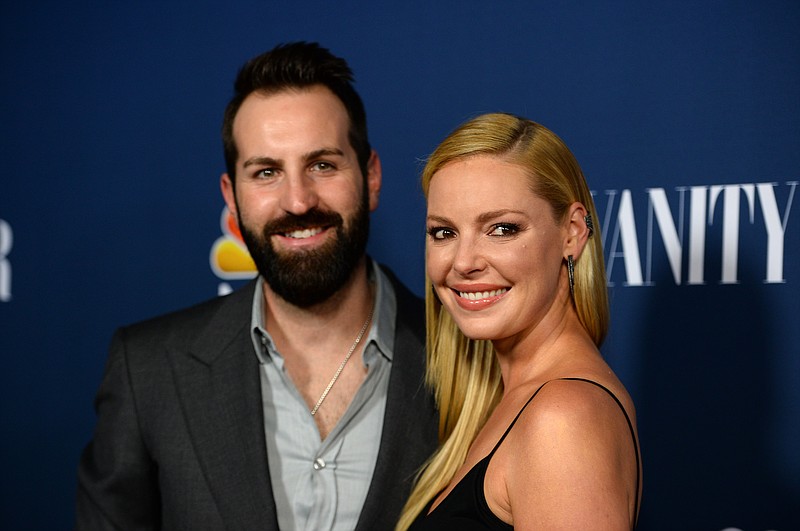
[76,269,438,531]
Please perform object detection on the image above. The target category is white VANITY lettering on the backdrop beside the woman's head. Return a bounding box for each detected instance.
[592,181,800,286]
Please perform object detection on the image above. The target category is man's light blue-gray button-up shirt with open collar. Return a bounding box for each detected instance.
[251,262,390,531]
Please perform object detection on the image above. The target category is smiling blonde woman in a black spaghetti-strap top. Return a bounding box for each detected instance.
[397,114,641,531]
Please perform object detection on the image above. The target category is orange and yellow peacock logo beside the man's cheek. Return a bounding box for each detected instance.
[209,207,256,295]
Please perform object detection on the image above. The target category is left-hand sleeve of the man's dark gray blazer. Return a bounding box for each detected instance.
[75,329,160,531]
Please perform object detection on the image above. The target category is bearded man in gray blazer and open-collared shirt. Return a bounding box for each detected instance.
[77,43,437,530]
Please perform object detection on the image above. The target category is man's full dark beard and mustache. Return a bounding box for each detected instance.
[237,193,369,308]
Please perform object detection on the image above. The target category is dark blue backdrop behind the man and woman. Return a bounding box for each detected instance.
[0,0,800,531]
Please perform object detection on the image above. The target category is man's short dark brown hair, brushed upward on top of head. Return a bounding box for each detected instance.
[222,41,372,179]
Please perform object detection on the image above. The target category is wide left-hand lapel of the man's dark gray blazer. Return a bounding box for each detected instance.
[171,282,278,529]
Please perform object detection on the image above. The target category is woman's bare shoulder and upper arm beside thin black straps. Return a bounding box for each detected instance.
[487,380,636,529]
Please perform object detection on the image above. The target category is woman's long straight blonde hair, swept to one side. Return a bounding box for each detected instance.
[397,113,609,530]
